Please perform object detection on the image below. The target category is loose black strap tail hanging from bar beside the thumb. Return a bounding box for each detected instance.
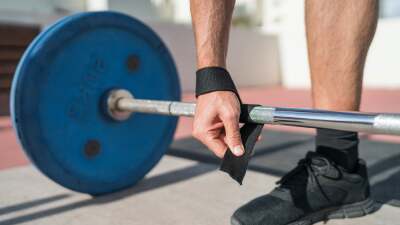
[220,104,264,184]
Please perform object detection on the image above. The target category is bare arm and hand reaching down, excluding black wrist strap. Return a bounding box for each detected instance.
[190,0,244,158]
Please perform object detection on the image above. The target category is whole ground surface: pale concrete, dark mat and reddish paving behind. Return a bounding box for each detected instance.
[0,88,400,225]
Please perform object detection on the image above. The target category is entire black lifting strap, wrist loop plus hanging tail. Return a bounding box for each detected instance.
[196,67,264,184]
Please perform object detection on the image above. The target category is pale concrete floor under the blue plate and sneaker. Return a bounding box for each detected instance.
[0,156,400,225]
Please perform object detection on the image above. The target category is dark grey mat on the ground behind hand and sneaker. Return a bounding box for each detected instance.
[168,131,400,207]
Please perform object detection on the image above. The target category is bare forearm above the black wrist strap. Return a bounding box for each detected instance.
[190,0,235,68]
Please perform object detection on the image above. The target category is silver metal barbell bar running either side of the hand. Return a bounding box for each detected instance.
[116,98,400,135]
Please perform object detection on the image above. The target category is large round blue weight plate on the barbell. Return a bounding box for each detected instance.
[11,12,180,195]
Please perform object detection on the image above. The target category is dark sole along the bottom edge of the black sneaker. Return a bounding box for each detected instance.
[231,198,379,225]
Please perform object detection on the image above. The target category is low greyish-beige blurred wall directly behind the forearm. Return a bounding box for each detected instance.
[150,23,280,91]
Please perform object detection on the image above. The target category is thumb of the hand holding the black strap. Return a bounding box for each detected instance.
[222,116,244,156]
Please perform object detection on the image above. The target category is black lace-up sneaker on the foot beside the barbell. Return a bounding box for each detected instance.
[231,152,377,225]
